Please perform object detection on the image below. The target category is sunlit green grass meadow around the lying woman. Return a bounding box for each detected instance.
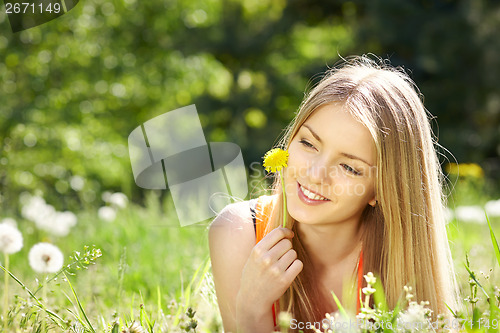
[0,164,500,333]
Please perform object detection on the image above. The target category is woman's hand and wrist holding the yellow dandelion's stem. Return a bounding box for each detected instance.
[236,227,303,326]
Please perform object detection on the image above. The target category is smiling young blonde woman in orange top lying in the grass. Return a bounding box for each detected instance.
[209,57,458,333]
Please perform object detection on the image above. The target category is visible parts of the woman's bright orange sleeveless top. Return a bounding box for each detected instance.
[252,195,363,327]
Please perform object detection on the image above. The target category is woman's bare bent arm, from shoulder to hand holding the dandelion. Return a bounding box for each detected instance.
[209,202,302,333]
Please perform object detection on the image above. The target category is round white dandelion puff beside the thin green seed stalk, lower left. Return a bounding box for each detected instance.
[28,243,64,273]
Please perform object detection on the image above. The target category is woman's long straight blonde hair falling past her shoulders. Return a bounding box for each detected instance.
[268,56,459,322]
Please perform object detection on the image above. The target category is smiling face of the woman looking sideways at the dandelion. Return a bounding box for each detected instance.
[284,104,376,224]
